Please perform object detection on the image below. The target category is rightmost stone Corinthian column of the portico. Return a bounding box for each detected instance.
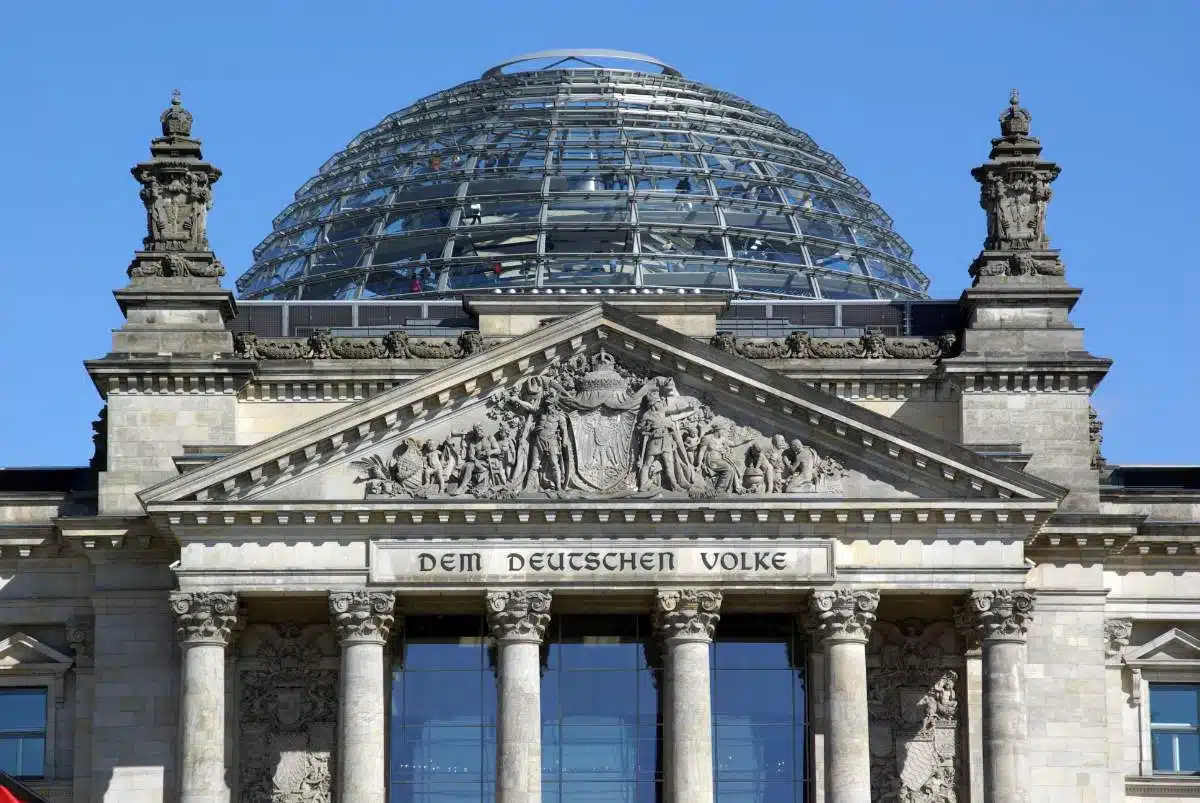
[967,588,1033,803]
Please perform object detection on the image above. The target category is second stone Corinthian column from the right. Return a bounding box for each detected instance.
[809,588,880,803]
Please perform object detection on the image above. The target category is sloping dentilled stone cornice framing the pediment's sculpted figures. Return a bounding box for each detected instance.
[139,305,1063,504]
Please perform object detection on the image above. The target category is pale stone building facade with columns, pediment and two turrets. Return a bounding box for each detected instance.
[0,64,1200,803]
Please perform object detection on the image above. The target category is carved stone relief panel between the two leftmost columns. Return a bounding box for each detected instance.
[238,624,338,803]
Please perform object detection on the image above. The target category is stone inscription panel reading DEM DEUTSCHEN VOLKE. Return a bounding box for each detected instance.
[371,540,833,587]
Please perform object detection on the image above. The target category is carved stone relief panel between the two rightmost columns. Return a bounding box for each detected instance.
[868,619,962,803]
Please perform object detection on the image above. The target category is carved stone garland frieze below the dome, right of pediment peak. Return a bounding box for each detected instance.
[708,331,959,360]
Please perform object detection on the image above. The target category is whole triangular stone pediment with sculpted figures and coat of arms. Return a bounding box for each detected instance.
[139,305,1063,510]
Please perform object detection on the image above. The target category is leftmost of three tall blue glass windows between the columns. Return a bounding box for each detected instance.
[388,616,496,803]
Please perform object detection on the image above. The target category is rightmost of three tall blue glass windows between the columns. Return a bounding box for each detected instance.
[712,615,806,803]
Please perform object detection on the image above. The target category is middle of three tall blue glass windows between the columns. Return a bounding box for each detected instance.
[541,616,661,803]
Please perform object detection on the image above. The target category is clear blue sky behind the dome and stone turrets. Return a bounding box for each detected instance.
[0,0,1200,466]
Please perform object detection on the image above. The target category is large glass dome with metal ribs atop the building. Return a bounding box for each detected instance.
[238,50,929,300]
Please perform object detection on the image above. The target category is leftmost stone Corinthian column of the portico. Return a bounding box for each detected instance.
[170,592,238,803]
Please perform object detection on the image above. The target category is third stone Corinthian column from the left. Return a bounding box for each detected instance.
[487,591,551,803]
